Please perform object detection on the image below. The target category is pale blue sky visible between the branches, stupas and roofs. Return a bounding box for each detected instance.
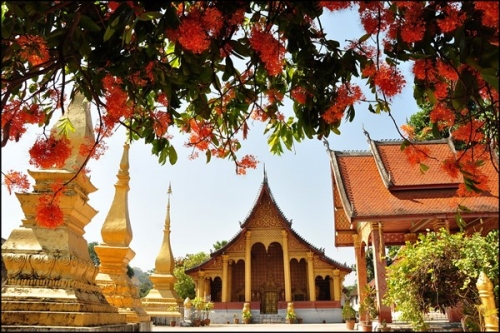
[1,7,418,285]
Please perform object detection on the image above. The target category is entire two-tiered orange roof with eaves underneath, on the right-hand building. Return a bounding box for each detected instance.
[330,139,499,246]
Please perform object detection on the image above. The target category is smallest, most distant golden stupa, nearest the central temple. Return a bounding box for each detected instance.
[142,185,182,318]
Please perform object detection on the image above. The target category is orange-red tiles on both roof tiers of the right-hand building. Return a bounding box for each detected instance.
[331,141,499,223]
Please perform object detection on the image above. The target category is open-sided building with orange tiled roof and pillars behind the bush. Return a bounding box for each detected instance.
[329,133,499,323]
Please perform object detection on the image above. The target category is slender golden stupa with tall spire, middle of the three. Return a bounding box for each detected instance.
[94,144,152,331]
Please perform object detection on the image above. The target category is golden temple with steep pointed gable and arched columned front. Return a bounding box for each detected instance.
[186,171,352,323]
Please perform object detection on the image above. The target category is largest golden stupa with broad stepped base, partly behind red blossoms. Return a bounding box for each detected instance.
[2,94,129,332]
